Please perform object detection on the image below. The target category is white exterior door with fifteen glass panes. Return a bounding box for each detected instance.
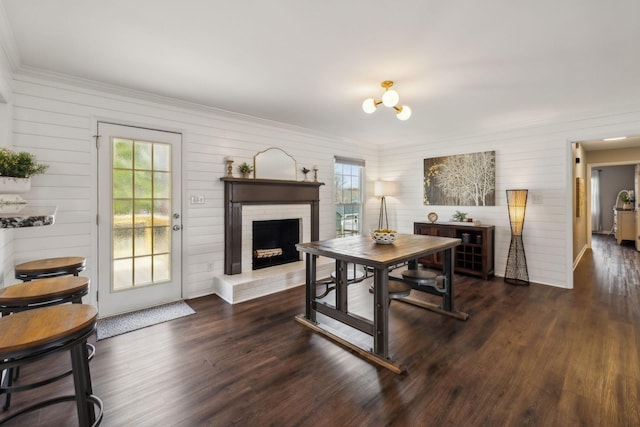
[98,122,182,317]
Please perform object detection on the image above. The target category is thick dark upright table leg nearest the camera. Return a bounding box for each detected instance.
[373,268,389,359]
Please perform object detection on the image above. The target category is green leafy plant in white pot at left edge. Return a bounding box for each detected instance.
[0,148,49,204]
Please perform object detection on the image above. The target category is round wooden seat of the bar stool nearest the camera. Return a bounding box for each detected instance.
[0,304,98,360]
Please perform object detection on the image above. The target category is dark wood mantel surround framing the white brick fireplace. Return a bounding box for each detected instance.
[220,177,324,274]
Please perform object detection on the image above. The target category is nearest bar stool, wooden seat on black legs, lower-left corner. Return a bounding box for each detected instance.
[0,304,104,427]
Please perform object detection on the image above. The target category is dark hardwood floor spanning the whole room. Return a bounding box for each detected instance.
[2,236,640,426]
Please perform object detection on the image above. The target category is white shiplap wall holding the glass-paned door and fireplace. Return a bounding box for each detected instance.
[7,75,377,302]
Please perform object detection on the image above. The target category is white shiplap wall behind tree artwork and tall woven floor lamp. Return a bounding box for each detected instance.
[380,111,640,288]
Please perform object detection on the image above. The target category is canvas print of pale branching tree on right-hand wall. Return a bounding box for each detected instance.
[423,151,496,206]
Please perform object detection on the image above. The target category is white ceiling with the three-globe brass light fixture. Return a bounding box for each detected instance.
[0,0,640,144]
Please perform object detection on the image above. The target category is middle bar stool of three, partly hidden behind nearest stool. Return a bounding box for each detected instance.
[0,276,95,411]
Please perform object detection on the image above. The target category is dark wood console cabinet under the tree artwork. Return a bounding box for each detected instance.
[413,222,495,280]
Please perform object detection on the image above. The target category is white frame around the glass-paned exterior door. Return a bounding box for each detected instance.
[87,115,188,317]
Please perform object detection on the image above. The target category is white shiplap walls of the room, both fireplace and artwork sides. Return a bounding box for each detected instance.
[7,70,640,297]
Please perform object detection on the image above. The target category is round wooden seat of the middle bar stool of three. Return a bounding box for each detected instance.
[0,276,89,308]
